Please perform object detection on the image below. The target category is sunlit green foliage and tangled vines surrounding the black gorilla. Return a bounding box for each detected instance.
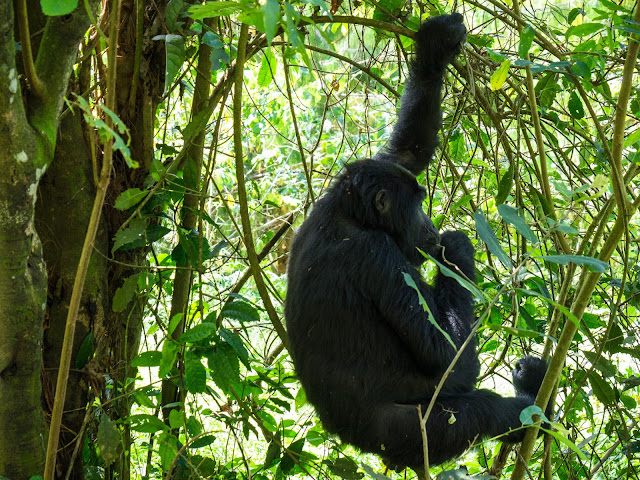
[10,0,640,479]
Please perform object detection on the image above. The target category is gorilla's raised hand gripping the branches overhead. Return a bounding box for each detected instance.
[415,13,467,72]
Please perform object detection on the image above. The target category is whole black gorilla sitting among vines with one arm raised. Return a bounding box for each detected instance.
[285,13,546,467]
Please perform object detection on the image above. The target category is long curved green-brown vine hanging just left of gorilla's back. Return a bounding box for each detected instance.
[233,23,289,346]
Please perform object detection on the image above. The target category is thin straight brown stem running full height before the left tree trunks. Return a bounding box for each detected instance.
[44,0,120,480]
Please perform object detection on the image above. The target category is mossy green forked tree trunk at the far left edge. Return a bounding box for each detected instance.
[0,2,96,478]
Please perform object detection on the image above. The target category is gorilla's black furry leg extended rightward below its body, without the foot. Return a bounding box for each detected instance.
[363,390,531,469]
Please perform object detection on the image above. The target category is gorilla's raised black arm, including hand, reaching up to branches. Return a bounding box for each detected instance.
[377,13,466,175]
